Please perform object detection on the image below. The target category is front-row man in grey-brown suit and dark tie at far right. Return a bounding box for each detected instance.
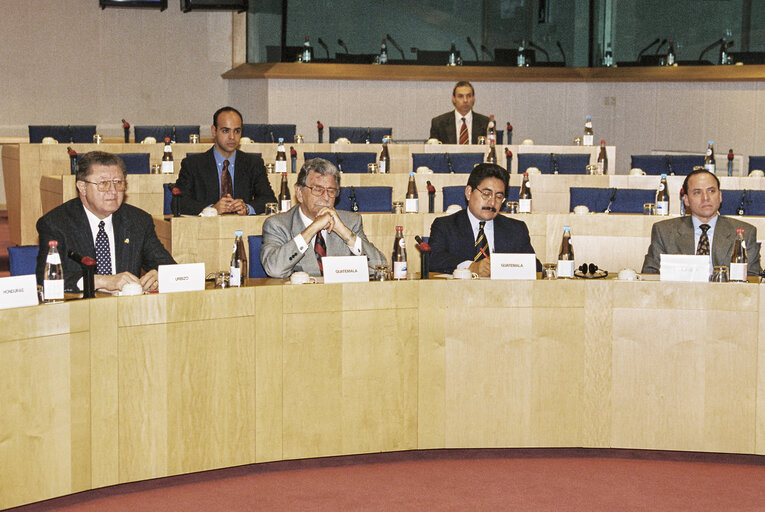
[643,169,760,276]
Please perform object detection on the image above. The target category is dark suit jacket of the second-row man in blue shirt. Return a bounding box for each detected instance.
[177,148,276,215]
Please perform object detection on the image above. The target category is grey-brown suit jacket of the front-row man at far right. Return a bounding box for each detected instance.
[643,215,760,275]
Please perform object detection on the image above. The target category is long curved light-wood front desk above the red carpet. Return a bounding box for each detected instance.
[0,280,765,508]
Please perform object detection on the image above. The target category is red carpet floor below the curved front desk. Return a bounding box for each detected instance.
[8,450,765,512]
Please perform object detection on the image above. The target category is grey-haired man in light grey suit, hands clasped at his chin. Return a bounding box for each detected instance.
[260,158,386,278]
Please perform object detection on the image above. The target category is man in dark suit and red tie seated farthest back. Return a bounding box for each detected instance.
[430,81,489,144]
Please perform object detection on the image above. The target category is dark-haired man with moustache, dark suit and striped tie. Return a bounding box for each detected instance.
[430,164,542,277]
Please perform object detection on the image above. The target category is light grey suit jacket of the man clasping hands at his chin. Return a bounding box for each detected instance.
[260,205,387,278]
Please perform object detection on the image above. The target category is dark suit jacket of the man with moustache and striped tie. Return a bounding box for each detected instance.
[430,210,542,274]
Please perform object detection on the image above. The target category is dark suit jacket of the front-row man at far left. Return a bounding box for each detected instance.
[37,198,175,290]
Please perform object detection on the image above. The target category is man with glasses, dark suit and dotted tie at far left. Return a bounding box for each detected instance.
[37,151,175,291]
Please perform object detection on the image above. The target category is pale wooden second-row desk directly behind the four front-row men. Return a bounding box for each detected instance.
[154,211,765,278]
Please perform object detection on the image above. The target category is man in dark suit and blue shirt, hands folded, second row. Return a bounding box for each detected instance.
[177,107,276,215]
